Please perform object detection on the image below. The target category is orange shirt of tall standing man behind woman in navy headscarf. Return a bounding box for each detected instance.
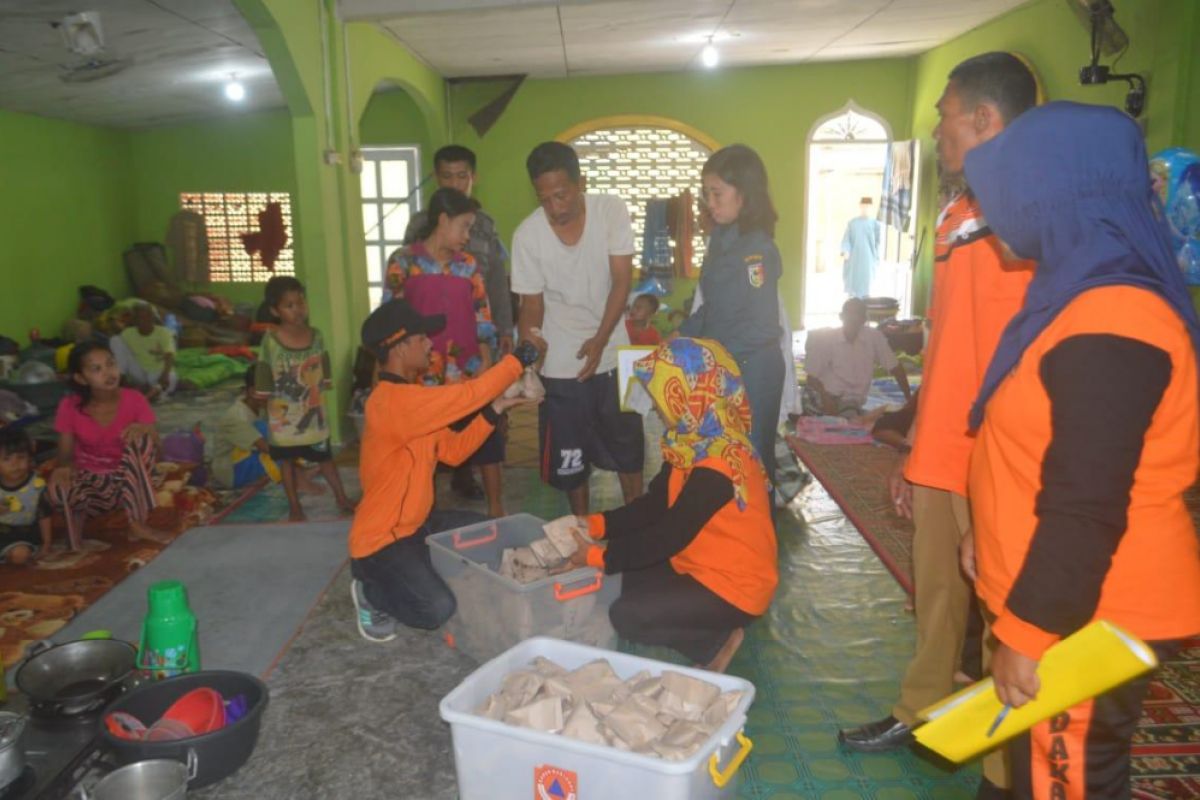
[905,193,1033,495]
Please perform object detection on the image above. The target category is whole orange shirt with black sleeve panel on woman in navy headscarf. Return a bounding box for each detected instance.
[970,285,1200,658]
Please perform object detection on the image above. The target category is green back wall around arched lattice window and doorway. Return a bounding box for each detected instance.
[451,59,913,320]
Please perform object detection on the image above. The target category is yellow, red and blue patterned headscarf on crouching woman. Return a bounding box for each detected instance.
[634,337,761,509]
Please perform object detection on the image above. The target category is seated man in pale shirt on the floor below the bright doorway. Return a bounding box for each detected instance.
[804,297,911,416]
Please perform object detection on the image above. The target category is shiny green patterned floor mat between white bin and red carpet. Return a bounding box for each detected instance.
[730,483,979,800]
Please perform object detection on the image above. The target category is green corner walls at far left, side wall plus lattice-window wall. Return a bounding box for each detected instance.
[0,109,302,343]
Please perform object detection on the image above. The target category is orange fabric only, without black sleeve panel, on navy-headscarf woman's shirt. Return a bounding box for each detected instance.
[970,285,1200,657]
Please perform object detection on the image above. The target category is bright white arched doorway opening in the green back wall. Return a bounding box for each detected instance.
[804,101,911,330]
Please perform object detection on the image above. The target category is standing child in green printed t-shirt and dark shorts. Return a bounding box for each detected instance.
[254,275,354,522]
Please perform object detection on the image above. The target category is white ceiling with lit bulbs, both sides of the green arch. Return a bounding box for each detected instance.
[0,0,1026,128]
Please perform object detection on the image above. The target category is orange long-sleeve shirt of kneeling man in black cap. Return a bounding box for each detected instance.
[350,355,521,558]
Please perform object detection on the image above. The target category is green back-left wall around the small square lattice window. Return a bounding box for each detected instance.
[130,109,297,302]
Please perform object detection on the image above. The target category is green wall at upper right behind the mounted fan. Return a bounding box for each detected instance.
[912,0,1200,305]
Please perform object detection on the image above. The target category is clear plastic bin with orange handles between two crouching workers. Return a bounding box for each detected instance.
[426,513,620,662]
